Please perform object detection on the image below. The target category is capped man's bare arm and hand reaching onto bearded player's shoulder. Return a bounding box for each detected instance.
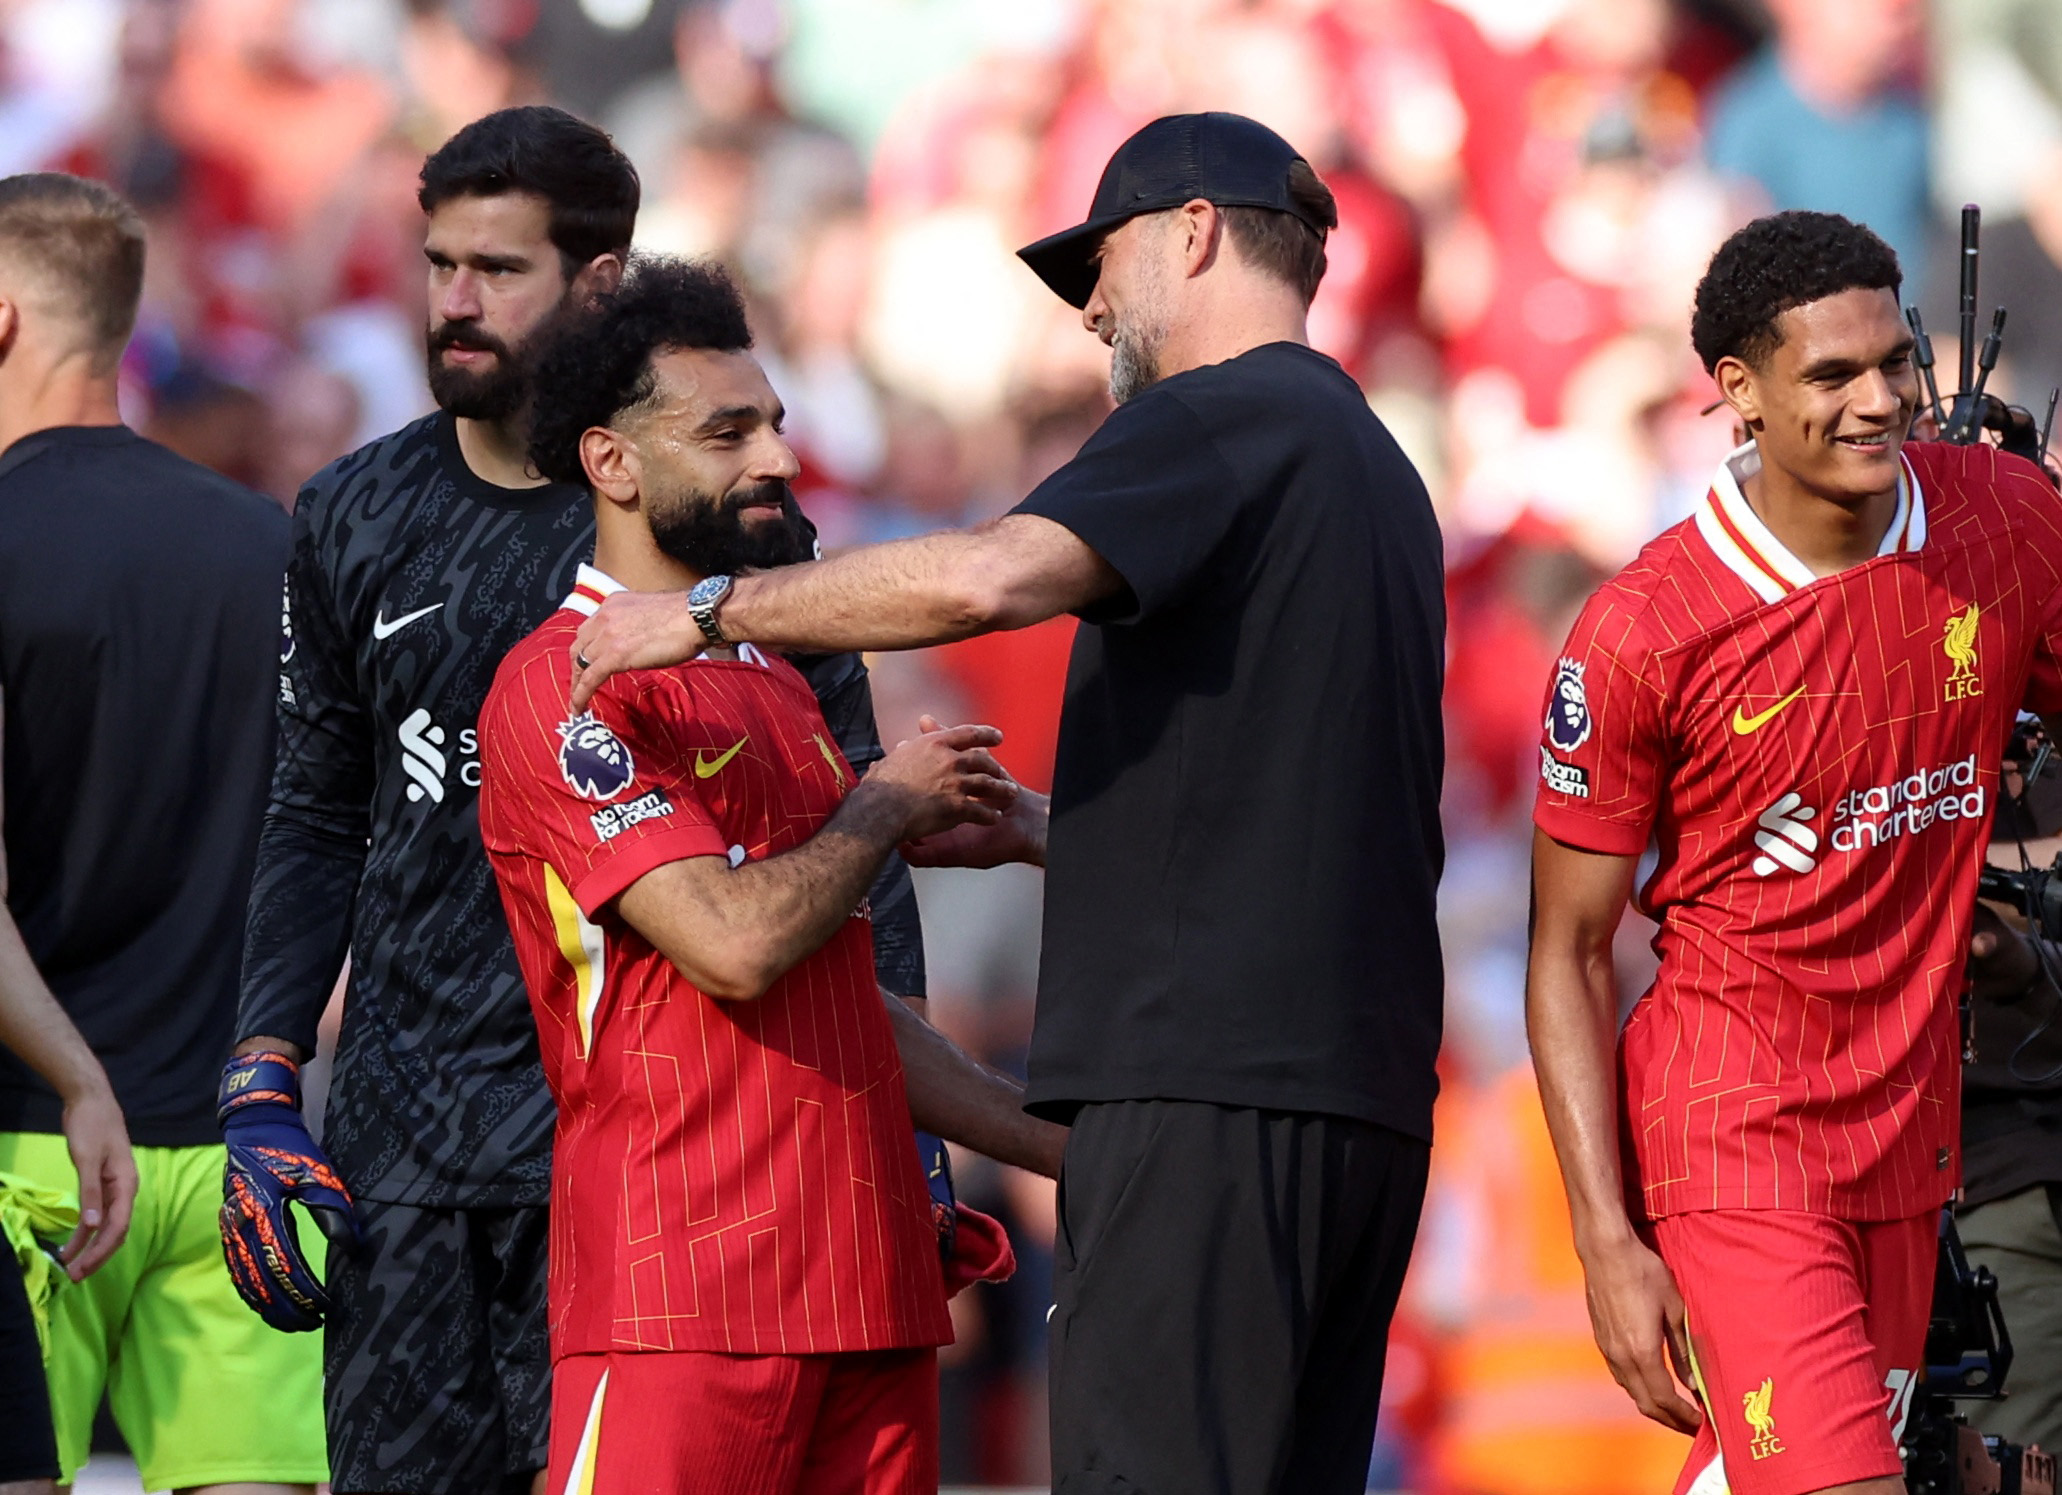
[573,513,1124,711]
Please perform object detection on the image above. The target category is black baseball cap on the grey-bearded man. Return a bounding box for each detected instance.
[1017,113,1332,307]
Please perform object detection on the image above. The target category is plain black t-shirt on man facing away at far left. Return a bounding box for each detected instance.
[0,427,287,1147]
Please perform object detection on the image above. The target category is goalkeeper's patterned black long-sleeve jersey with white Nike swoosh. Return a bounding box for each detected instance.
[237,412,924,1208]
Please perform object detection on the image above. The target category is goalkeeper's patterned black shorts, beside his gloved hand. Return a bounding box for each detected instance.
[322,1200,551,1495]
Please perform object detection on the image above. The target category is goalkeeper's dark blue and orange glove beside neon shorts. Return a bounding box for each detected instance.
[214,1052,363,1330]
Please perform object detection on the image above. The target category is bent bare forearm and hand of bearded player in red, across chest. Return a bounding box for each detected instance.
[617,726,1017,1002]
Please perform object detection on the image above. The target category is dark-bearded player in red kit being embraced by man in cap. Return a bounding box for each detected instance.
[480,262,1062,1495]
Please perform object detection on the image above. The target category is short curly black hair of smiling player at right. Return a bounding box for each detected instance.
[1689,212,1905,373]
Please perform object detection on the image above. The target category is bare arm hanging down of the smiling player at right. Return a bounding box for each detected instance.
[1526,831,1703,1433]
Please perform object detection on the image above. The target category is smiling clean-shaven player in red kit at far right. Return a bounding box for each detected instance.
[1528,212,2062,1495]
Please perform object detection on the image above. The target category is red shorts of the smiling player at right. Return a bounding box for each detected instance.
[1652,1210,1940,1495]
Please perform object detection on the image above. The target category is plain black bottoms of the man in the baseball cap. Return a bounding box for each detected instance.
[1052,1101,1431,1495]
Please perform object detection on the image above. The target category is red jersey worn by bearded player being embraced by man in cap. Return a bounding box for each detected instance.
[480,567,953,1357]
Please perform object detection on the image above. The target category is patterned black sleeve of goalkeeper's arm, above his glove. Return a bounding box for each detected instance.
[237,487,373,1052]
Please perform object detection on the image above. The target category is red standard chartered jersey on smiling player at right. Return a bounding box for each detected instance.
[1534,445,2062,1219]
